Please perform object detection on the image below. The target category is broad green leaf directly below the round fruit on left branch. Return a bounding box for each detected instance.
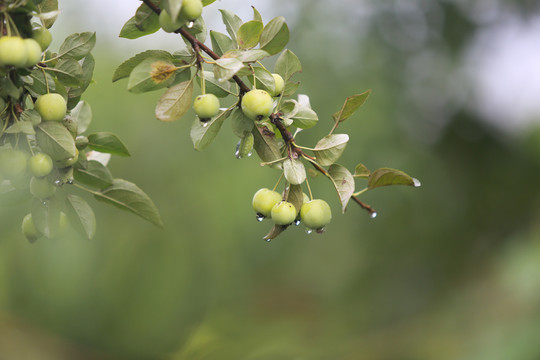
[36,121,76,160]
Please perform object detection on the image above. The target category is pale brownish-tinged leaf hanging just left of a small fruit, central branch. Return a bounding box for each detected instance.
[155,79,193,122]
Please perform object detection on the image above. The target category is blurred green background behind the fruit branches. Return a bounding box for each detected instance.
[0,0,540,360]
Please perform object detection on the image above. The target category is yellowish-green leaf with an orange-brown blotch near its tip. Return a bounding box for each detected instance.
[128,58,176,94]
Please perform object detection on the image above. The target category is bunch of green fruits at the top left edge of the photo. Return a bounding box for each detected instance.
[0,27,52,68]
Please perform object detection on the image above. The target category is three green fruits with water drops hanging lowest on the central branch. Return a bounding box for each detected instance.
[252,188,332,232]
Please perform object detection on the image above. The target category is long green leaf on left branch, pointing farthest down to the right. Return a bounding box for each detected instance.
[94,179,163,227]
